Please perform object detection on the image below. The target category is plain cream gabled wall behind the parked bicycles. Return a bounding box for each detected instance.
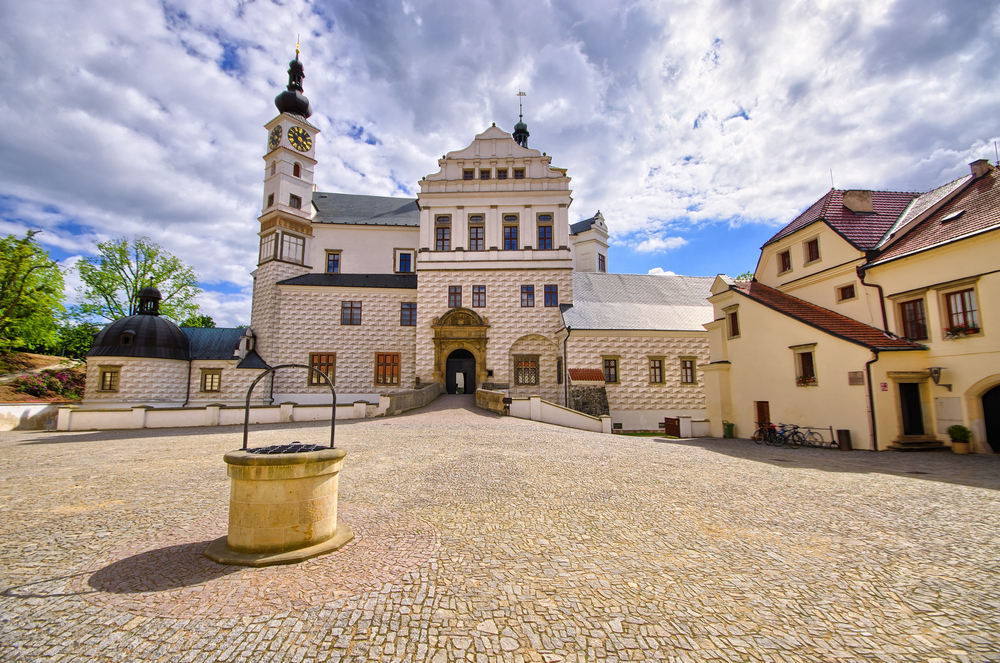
[705,292,876,449]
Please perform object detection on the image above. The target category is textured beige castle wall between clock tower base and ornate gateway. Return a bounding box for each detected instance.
[264,286,419,403]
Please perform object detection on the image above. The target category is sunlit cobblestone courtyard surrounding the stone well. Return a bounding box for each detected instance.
[0,396,1000,663]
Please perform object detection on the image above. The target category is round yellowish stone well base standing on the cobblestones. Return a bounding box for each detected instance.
[205,449,354,566]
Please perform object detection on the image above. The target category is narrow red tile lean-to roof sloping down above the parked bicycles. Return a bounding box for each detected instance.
[730,281,927,350]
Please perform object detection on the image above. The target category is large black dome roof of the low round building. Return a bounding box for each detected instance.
[87,314,191,361]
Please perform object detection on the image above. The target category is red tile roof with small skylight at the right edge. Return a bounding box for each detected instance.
[872,168,1000,264]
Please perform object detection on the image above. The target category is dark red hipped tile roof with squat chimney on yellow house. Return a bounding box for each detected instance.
[764,189,919,251]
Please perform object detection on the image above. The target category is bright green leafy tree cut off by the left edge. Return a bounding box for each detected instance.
[0,230,64,350]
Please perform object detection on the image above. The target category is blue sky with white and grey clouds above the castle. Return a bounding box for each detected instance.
[0,0,1000,326]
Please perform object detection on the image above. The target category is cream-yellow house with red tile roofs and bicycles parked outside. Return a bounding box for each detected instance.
[703,160,1000,453]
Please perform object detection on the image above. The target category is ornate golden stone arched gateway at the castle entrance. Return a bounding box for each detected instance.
[431,308,490,394]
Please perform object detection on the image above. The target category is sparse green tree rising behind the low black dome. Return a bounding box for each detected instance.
[77,235,201,321]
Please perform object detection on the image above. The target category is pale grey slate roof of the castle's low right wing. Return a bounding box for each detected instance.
[561,273,715,332]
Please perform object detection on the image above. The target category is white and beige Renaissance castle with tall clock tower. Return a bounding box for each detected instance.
[85,57,713,430]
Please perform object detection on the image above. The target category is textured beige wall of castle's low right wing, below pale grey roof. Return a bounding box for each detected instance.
[567,330,709,430]
